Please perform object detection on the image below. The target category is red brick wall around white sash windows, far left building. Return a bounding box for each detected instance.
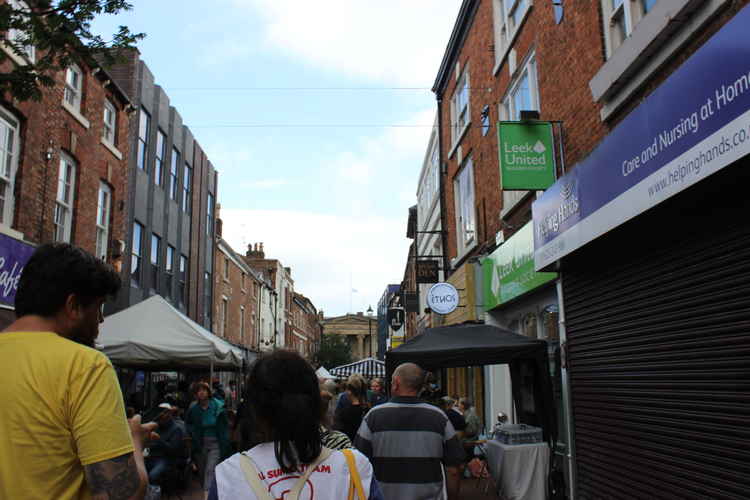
[0,53,129,266]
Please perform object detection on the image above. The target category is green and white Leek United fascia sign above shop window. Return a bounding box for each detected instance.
[482,222,557,311]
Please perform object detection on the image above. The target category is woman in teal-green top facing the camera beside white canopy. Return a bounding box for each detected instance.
[185,382,232,493]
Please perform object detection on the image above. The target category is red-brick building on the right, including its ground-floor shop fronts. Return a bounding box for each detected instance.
[433,0,750,498]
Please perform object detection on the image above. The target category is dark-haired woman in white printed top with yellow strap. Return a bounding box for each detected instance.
[209,350,383,500]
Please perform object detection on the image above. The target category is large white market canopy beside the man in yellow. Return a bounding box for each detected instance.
[97,295,251,370]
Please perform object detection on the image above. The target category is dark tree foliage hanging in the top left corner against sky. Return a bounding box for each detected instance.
[0,0,145,101]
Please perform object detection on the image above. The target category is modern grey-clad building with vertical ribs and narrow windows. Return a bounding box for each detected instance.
[110,51,217,330]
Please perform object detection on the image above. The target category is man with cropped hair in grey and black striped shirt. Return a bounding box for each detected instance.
[354,363,464,500]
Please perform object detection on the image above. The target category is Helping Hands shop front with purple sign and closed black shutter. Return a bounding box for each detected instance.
[533,8,750,499]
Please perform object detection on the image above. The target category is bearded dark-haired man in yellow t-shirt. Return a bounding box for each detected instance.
[0,243,155,500]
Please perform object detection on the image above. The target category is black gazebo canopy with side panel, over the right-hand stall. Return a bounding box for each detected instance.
[385,323,557,439]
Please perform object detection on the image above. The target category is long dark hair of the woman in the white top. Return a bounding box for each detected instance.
[243,350,322,472]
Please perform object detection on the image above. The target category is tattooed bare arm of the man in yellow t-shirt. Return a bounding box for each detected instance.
[84,453,148,500]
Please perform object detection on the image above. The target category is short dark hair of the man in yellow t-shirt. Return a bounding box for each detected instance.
[15,243,122,318]
